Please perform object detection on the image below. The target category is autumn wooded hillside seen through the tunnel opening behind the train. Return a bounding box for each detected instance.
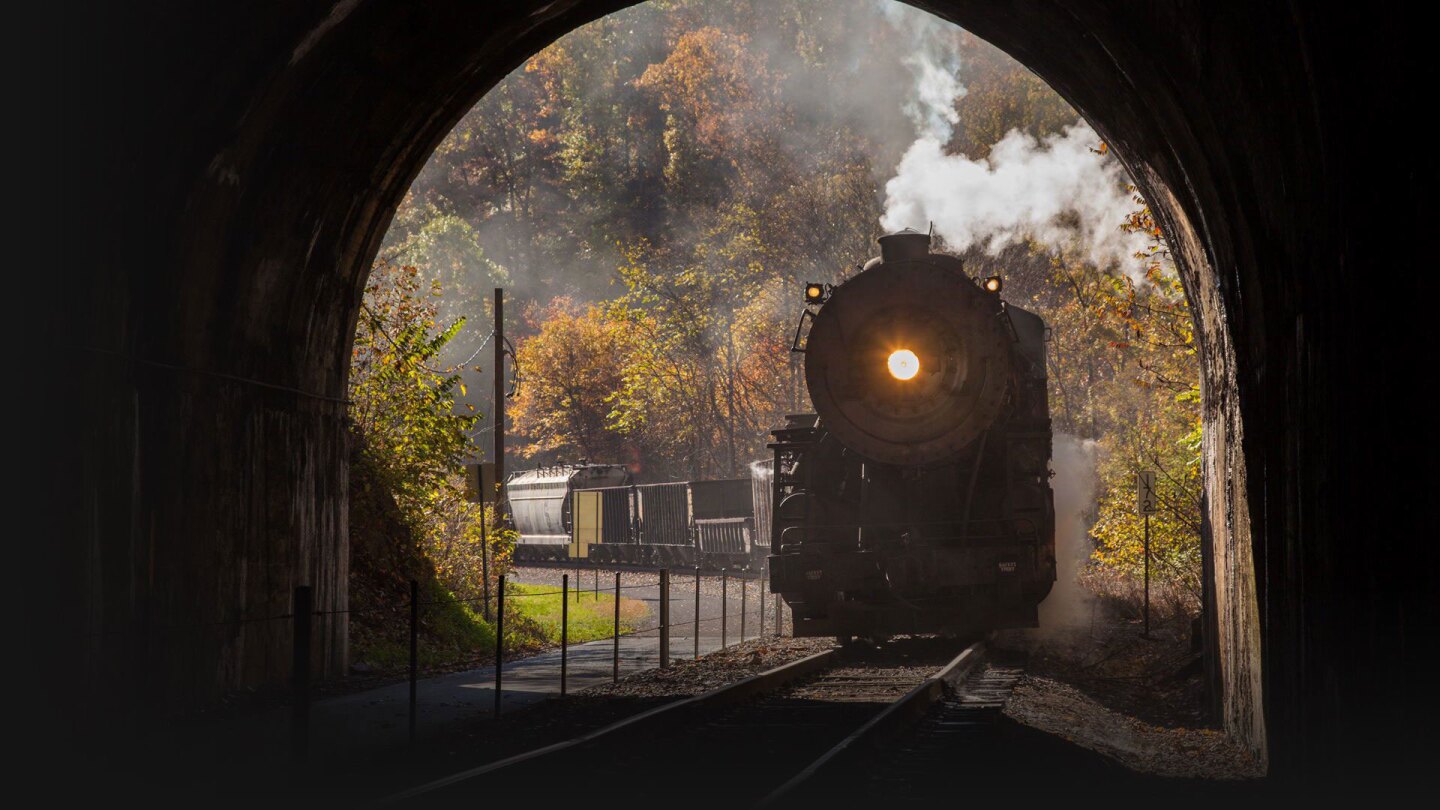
[351,0,1201,643]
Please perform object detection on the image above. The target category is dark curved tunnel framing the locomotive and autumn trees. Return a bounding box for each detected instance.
[50,0,1440,780]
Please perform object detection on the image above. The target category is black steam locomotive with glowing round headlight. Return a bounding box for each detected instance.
[769,229,1056,638]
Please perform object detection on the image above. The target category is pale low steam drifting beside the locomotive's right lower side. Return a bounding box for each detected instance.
[1030,434,1099,641]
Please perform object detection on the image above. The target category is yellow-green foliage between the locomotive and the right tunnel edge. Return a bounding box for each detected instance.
[1014,200,1202,604]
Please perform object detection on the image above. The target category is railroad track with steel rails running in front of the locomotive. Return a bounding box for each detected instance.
[387,638,984,807]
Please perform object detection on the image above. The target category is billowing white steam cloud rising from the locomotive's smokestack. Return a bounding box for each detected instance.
[881,7,1145,276]
